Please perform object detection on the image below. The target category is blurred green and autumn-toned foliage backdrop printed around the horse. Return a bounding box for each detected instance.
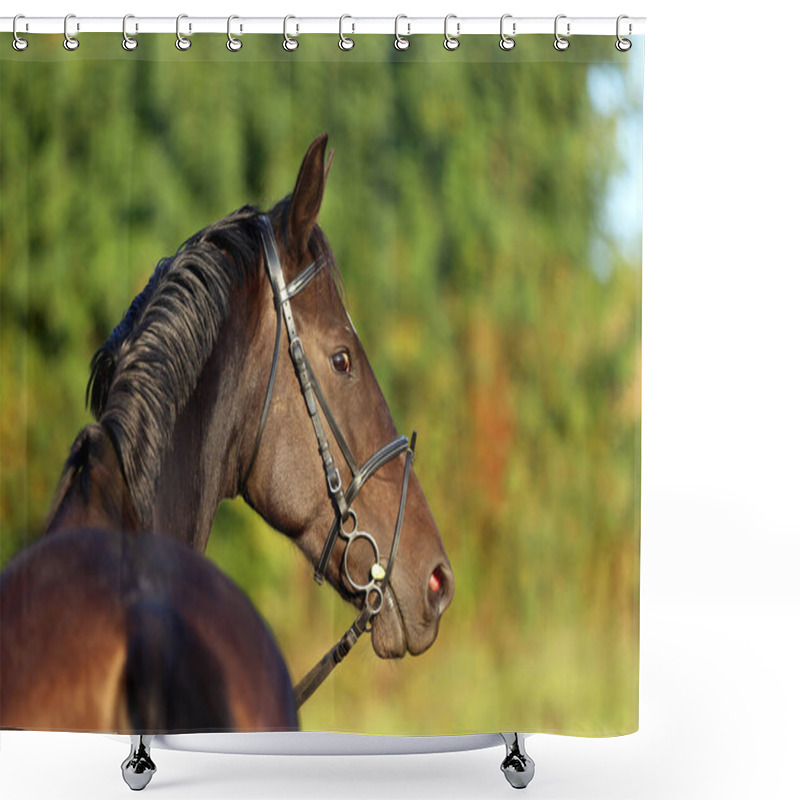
[0,29,643,736]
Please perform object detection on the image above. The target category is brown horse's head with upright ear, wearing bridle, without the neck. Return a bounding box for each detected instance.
[242,135,454,658]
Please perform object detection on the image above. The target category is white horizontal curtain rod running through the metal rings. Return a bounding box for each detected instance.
[0,14,645,37]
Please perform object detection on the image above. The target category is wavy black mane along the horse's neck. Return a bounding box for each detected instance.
[86,206,262,529]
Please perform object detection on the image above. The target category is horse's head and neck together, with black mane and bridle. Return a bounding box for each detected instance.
[87,134,454,664]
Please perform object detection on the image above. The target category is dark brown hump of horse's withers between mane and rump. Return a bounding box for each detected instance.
[45,424,137,533]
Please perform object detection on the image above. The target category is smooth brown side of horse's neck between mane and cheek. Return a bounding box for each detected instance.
[153,290,263,551]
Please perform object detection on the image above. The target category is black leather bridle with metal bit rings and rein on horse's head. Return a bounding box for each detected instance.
[241,214,417,708]
